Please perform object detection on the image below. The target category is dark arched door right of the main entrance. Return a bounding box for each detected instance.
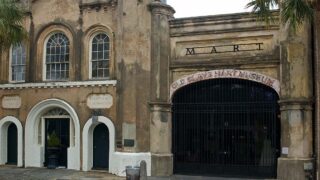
[93,123,109,169]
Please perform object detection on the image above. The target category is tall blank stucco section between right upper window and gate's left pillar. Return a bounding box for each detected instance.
[116,0,151,152]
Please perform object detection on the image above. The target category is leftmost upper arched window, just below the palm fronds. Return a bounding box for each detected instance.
[10,44,26,82]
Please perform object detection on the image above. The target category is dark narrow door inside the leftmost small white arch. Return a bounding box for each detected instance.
[7,123,18,165]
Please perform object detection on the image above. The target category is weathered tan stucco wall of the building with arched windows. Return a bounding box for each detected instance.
[0,0,152,155]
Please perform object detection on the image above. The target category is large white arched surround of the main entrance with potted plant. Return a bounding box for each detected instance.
[25,99,80,170]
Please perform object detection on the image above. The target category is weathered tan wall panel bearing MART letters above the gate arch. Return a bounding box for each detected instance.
[170,12,280,86]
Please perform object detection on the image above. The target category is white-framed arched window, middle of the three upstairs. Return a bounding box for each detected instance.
[45,33,70,80]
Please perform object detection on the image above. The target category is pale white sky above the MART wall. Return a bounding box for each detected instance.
[167,0,250,18]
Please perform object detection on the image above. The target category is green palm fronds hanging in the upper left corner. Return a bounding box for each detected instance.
[0,0,27,49]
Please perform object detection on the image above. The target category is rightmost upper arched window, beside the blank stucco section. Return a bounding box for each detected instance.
[90,33,110,79]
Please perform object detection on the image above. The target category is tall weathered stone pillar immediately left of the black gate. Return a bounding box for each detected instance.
[149,0,174,176]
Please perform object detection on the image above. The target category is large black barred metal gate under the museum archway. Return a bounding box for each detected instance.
[172,79,280,178]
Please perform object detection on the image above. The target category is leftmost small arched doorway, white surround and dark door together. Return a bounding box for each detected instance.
[0,116,23,167]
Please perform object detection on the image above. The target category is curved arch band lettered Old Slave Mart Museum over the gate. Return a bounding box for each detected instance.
[170,69,280,99]
